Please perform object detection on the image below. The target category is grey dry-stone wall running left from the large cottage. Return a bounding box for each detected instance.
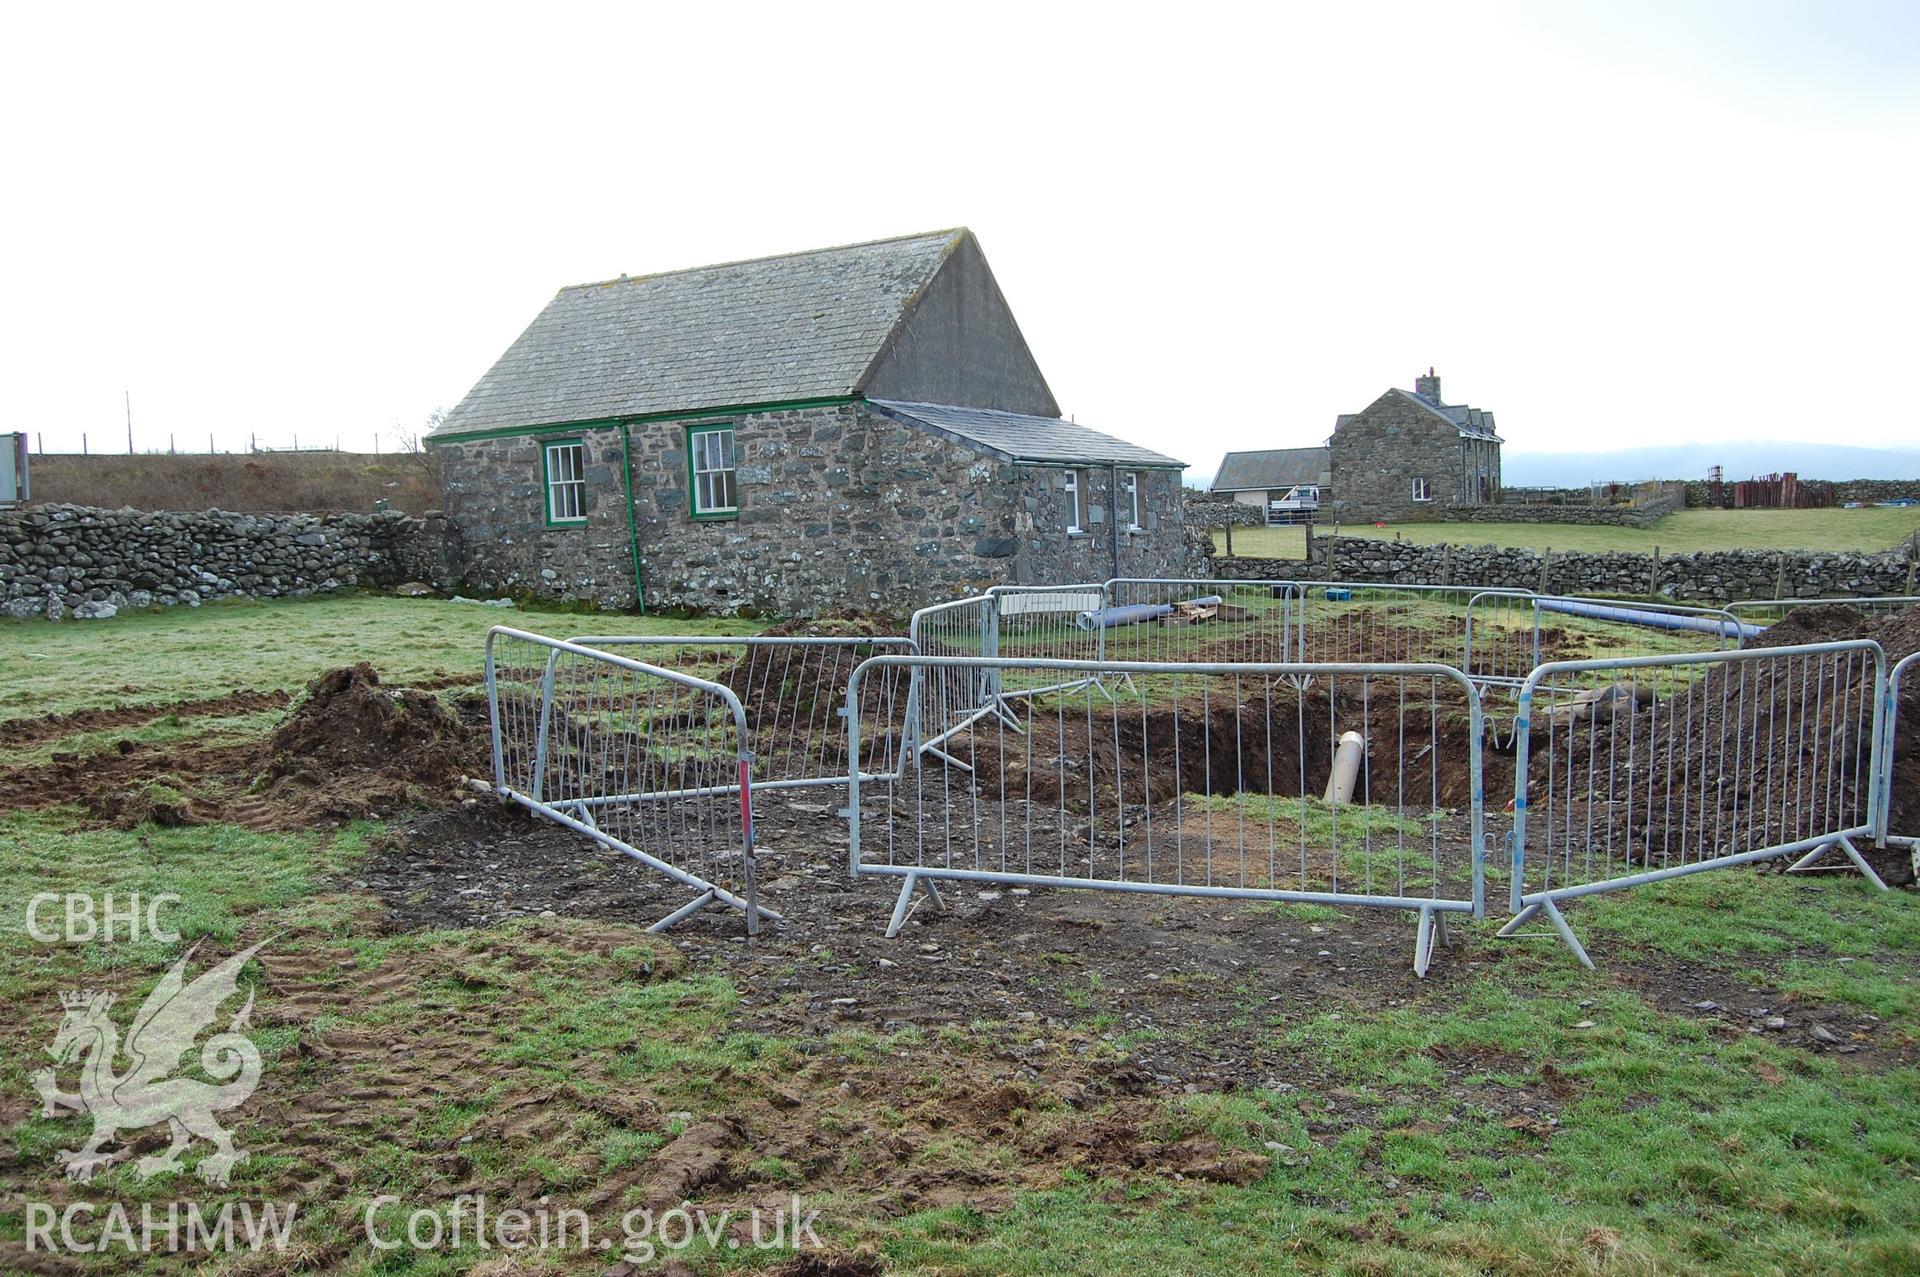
[0,505,441,620]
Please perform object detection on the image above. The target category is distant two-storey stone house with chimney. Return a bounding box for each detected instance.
[1327,369,1501,522]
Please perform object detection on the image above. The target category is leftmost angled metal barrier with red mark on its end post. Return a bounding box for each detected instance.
[486,626,780,935]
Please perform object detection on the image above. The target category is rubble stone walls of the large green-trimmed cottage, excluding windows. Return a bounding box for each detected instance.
[440,405,1194,616]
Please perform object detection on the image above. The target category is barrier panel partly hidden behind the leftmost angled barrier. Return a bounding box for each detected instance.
[566,634,914,789]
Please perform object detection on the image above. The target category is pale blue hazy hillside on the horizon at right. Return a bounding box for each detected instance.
[1500,444,1920,488]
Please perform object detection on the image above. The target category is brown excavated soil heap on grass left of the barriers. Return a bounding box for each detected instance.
[0,664,488,830]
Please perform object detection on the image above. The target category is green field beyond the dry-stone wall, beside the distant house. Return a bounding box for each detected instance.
[1213,507,1920,559]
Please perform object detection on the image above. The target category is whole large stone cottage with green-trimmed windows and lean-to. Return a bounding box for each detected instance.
[428,229,1198,616]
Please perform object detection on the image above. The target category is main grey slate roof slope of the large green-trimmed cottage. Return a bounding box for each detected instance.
[434,229,968,438]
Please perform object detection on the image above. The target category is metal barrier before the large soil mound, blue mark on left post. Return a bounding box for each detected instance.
[1500,639,1887,966]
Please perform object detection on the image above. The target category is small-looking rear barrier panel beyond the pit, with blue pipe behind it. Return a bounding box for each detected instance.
[1105,576,1300,663]
